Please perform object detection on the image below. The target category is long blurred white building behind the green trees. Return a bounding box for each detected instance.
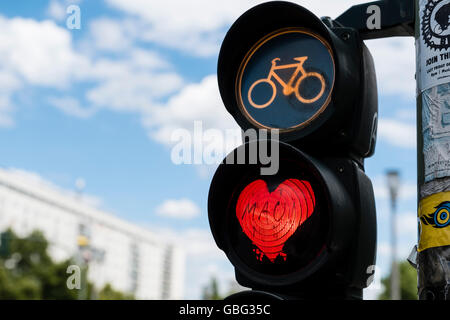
[0,169,184,299]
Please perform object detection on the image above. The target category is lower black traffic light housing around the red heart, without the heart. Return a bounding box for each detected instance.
[208,141,376,298]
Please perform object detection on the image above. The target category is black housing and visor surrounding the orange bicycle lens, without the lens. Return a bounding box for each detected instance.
[218,1,378,161]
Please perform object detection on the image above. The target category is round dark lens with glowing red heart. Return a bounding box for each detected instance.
[227,162,329,276]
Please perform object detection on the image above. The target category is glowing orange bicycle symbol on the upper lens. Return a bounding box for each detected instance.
[248,57,325,109]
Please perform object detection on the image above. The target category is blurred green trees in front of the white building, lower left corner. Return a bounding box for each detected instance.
[0,230,134,300]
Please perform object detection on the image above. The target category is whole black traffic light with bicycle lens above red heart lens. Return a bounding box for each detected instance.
[208,1,378,299]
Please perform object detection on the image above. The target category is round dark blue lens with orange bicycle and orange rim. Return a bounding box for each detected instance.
[236,28,335,131]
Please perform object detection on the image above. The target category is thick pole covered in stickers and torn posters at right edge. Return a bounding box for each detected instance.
[415,0,450,300]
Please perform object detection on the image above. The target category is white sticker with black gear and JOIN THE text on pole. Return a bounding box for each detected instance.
[416,0,450,94]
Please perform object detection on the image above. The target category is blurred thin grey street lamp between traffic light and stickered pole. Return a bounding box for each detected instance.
[386,170,401,300]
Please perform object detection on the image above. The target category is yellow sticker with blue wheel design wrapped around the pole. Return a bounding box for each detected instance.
[418,191,450,251]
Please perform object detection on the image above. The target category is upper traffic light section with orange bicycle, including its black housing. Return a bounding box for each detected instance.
[218,1,378,158]
